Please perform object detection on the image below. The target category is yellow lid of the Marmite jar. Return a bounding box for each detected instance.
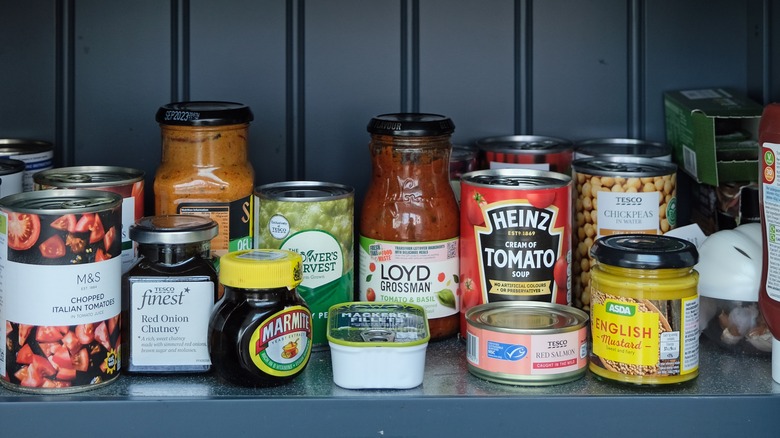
[219,249,303,289]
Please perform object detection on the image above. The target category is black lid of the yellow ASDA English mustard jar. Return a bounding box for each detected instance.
[590,234,699,269]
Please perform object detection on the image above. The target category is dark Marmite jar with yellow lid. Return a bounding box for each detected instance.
[209,249,312,387]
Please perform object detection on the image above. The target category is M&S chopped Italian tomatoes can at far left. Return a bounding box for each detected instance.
[0,190,122,394]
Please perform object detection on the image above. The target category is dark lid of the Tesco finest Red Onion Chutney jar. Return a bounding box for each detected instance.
[130,214,218,245]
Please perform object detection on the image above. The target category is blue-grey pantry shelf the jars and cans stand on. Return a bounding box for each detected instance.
[0,339,780,437]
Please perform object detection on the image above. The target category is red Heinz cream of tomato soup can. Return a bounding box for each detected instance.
[459,169,572,336]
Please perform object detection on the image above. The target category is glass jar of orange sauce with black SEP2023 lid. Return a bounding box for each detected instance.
[154,101,254,262]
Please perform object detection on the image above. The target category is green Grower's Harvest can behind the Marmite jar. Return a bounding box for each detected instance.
[254,181,355,350]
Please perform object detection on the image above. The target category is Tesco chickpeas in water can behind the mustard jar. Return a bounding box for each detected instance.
[572,155,677,311]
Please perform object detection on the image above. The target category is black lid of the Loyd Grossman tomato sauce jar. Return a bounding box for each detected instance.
[368,113,455,137]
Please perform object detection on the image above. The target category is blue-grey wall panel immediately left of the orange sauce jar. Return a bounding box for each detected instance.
[73,0,171,188]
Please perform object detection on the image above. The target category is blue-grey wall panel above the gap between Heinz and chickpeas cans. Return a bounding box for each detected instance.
[531,0,630,140]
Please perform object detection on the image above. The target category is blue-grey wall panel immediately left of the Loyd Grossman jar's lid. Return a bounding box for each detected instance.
[303,0,408,198]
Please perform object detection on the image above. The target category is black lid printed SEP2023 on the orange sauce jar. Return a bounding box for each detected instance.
[155,101,254,126]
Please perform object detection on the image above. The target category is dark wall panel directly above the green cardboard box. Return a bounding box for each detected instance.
[644,0,747,140]
